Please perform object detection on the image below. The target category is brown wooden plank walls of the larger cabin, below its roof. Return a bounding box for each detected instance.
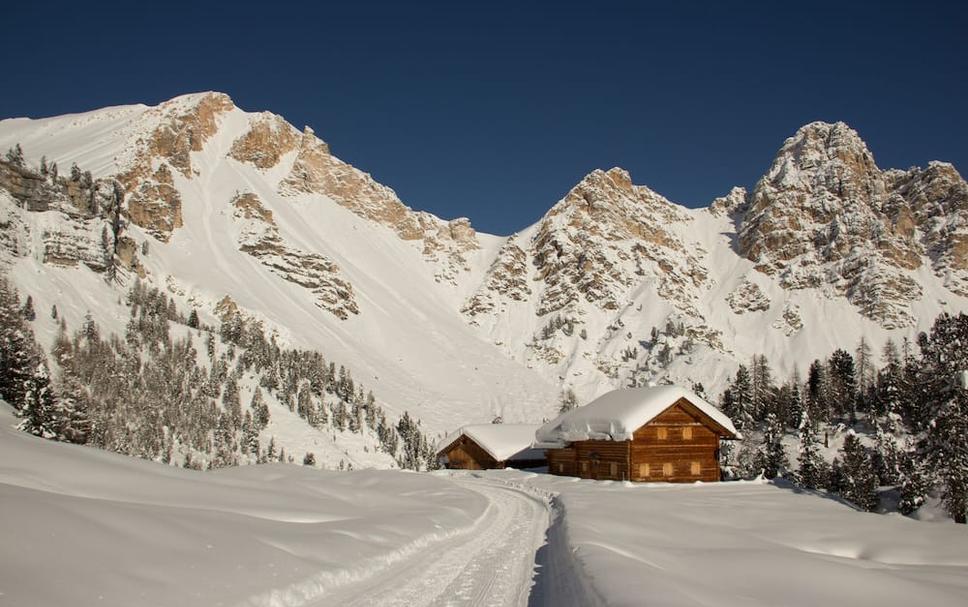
[547,399,722,483]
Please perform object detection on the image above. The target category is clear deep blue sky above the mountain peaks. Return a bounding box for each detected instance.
[0,0,968,234]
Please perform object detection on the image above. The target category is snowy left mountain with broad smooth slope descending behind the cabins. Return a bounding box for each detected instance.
[0,93,556,442]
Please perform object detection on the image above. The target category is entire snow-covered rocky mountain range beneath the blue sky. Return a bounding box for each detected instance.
[0,93,968,442]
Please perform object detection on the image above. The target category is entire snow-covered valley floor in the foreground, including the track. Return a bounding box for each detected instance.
[0,405,968,607]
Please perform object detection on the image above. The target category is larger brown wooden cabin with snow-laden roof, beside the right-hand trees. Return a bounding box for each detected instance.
[536,386,739,483]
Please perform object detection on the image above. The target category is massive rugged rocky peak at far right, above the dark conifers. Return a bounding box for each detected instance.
[739,122,968,328]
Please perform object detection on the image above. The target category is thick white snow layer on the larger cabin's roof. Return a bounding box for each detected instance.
[535,386,739,446]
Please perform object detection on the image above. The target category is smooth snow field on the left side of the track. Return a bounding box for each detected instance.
[0,402,487,606]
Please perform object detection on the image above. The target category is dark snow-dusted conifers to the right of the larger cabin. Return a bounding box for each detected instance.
[716,313,968,523]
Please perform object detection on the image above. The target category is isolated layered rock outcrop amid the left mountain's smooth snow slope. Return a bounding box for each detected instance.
[231,192,359,319]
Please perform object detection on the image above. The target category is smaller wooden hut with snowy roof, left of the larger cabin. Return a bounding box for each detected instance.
[437,424,546,470]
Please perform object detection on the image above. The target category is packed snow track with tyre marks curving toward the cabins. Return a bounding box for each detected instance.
[324,477,549,607]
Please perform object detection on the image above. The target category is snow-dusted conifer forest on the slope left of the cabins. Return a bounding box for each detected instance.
[0,277,436,476]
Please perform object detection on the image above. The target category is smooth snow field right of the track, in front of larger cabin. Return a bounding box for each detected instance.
[460,470,968,607]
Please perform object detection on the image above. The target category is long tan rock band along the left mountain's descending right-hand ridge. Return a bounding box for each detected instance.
[279,127,480,281]
